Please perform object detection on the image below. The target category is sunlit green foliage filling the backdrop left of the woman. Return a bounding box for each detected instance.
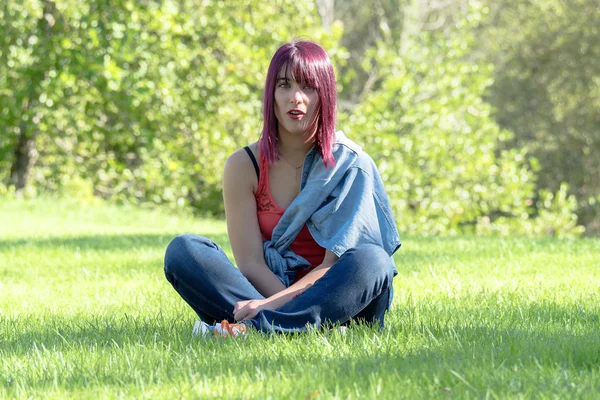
[0,0,343,213]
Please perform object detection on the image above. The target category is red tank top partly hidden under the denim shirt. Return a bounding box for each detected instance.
[255,152,325,282]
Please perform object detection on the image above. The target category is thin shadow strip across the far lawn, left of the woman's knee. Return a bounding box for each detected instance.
[0,233,229,252]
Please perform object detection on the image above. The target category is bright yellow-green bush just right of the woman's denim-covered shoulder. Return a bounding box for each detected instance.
[347,5,548,234]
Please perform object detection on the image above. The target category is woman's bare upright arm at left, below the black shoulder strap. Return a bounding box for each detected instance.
[223,150,285,297]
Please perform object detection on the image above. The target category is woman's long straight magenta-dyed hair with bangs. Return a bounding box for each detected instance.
[260,41,337,166]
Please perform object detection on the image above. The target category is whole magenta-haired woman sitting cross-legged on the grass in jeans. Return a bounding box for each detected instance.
[165,41,400,332]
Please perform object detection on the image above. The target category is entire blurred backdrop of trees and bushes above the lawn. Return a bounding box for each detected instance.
[0,0,600,237]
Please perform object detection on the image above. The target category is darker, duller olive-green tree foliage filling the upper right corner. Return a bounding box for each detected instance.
[478,0,600,233]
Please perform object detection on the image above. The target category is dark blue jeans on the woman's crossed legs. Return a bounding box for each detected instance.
[165,235,397,332]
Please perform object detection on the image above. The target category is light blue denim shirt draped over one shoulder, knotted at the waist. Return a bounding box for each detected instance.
[263,131,401,287]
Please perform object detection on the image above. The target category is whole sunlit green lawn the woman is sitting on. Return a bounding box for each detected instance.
[0,200,600,399]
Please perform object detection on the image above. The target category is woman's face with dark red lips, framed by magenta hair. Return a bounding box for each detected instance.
[275,68,319,137]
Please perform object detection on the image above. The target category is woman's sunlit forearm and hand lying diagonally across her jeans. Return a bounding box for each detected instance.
[233,250,339,321]
